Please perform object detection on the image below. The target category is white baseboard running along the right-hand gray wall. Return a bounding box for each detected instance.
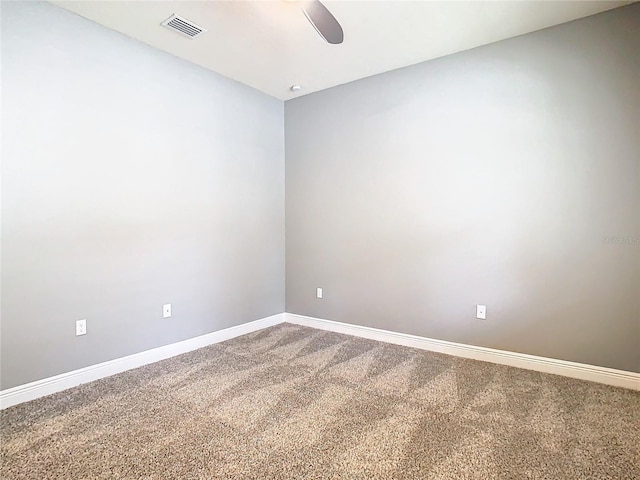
[285,313,640,390]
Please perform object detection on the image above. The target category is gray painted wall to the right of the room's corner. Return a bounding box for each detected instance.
[285,4,640,372]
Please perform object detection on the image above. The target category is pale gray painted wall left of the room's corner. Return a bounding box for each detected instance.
[1,2,284,389]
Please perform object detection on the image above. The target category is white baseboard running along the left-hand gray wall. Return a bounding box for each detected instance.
[0,313,285,409]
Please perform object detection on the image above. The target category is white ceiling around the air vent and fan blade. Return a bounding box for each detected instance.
[52,0,633,100]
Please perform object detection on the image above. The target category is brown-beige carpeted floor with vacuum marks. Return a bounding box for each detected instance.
[0,324,640,480]
